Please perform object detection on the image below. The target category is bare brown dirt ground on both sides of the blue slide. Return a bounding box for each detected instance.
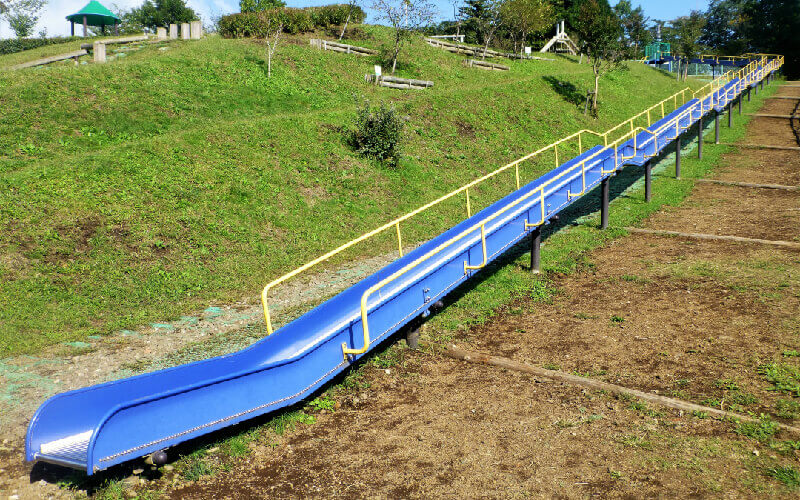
[0,84,800,499]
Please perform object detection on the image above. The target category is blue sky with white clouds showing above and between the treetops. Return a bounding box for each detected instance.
[0,0,708,38]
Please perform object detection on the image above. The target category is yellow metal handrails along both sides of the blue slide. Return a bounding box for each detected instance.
[261,56,783,340]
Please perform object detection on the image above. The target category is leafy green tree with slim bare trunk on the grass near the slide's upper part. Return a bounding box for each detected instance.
[575,0,624,115]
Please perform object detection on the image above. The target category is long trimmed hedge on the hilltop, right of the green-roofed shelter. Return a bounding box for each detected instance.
[219,4,367,38]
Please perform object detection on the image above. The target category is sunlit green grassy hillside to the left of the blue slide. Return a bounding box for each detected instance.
[0,27,700,355]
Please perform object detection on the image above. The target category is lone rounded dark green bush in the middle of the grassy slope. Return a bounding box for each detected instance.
[352,102,403,167]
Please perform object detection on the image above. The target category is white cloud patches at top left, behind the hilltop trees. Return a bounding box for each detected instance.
[0,0,239,38]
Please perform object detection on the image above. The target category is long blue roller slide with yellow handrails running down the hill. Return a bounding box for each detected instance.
[25,52,783,475]
